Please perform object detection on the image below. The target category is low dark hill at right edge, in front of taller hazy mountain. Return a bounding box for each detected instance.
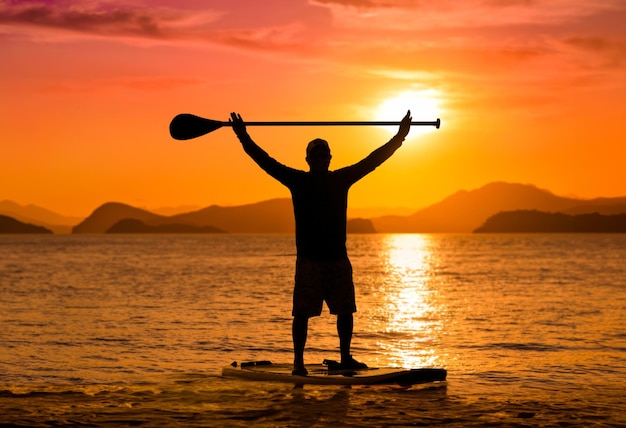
[474,210,626,233]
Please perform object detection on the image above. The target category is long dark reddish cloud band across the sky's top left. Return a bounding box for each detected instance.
[0,0,323,53]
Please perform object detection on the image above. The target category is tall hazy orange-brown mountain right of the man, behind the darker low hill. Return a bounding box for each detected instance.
[372,182,626,233]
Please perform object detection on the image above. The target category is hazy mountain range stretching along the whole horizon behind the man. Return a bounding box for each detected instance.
[0,182,626,233]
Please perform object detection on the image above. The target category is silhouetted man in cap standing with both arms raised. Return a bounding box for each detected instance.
[229,111,411,375]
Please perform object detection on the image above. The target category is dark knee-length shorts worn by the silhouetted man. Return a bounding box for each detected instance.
[292,257,356,317]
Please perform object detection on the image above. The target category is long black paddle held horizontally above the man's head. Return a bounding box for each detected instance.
[170,113,441,140]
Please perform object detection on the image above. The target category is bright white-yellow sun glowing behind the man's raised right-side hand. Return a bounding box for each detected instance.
[375,89,441,134]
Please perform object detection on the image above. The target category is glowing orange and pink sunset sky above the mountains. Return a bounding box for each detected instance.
[0,0,626,215]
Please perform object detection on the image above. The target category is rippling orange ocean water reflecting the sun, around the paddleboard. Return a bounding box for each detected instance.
[0,234,626,427]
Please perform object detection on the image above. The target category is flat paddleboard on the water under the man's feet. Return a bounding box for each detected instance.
[222,361,447,386]
